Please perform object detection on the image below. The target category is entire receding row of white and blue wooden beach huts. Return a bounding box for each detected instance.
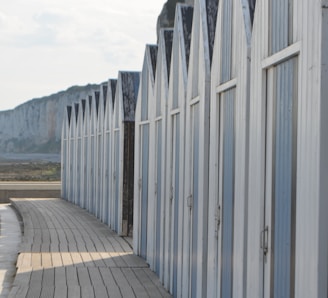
[62,0,328,298]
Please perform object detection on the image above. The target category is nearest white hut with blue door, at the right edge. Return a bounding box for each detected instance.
[247,0,328,298]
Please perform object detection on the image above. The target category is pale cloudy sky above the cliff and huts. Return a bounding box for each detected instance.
[0,0,166,111]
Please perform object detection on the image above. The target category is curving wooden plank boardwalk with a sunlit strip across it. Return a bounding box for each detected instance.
[9,199,171,298]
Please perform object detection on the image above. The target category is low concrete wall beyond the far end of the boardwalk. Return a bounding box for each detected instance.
[0,181,61,203]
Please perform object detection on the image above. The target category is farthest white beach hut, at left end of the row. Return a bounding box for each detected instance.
[61,106,72,200]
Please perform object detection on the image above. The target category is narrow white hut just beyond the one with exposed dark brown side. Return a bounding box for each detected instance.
[102,79,117,225]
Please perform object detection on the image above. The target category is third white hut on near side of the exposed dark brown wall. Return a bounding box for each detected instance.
[163,4,193,297]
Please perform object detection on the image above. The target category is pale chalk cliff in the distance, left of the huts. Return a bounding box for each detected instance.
[0,84,99,153]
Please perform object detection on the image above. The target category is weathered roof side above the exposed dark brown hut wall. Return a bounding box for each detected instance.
[120,72,140,121]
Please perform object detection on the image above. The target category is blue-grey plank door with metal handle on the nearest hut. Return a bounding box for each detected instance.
[261,58,298,298]
